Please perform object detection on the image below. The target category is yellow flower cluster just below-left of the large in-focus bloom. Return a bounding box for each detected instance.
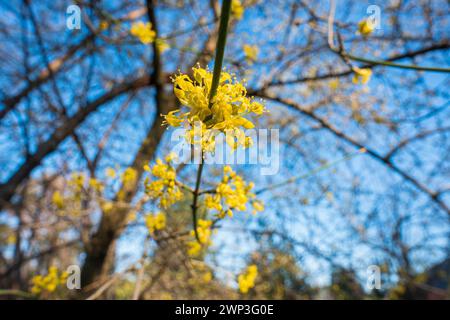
[144,153,183,209]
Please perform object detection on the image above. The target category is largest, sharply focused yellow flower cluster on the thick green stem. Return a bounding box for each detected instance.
[164,66,265,151]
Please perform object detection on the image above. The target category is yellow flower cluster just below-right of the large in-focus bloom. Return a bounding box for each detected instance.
[205,166,264,218]
